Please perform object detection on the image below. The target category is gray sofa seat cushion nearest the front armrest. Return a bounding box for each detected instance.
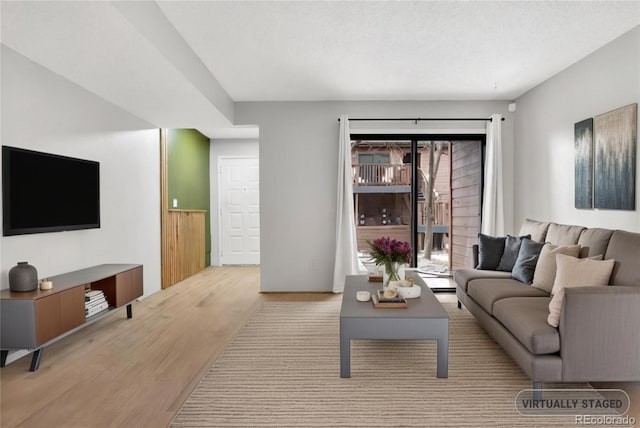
[493,297,560,355]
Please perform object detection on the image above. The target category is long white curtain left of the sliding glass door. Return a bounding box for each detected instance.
[333,114,361,293]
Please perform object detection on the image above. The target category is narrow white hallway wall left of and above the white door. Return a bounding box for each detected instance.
[209,139,259,266]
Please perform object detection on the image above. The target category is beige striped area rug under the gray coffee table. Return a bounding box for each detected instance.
[171,302,575,427]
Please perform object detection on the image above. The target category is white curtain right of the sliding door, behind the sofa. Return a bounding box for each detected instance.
[481,114,504,236]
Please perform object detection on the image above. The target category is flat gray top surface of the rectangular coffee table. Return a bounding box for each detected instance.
[340,273,449,318]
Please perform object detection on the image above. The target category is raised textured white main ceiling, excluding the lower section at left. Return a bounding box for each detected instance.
[159,1,640,101]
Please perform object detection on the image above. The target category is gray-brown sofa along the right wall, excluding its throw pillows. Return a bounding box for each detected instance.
[454,219,640,390]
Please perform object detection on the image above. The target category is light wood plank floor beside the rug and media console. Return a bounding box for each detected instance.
[0,267,640,428]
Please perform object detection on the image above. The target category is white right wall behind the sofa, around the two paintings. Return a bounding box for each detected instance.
[514,27,640,232]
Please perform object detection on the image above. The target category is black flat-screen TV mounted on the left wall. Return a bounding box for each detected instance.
[2,146,100,236]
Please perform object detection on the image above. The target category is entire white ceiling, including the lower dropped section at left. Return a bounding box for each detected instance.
[0,0,640,137]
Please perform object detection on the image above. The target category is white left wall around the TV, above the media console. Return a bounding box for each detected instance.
[0,46,160,296]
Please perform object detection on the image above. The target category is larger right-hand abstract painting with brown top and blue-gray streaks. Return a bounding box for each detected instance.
[596,103,638,210]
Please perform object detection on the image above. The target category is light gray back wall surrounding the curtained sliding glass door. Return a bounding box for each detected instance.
[235,101,513,292]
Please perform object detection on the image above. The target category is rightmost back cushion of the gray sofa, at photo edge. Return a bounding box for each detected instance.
[604,230,640,286]
